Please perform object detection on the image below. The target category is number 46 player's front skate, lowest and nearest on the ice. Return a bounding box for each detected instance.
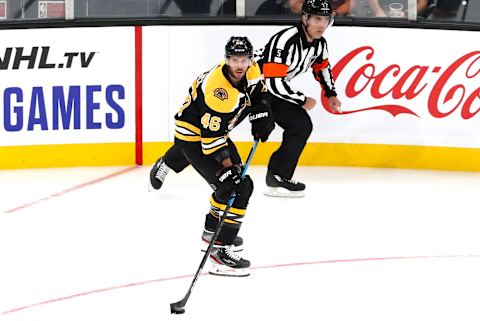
[209,246,250,276]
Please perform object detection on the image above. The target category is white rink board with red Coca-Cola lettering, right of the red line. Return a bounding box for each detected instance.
[138,25,480,148]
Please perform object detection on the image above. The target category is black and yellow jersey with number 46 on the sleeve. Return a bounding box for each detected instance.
[175,61,268,158]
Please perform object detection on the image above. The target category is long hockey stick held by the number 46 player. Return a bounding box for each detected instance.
[170,140,258,314]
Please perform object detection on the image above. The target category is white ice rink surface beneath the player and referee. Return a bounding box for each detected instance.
[0,166,480,321]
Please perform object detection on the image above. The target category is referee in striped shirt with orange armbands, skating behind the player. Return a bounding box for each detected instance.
[150,0,341,197]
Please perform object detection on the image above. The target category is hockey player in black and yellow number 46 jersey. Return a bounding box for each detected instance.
[168,37,274,276]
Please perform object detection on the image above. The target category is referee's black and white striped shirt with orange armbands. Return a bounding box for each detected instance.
[255,23,337,105]
